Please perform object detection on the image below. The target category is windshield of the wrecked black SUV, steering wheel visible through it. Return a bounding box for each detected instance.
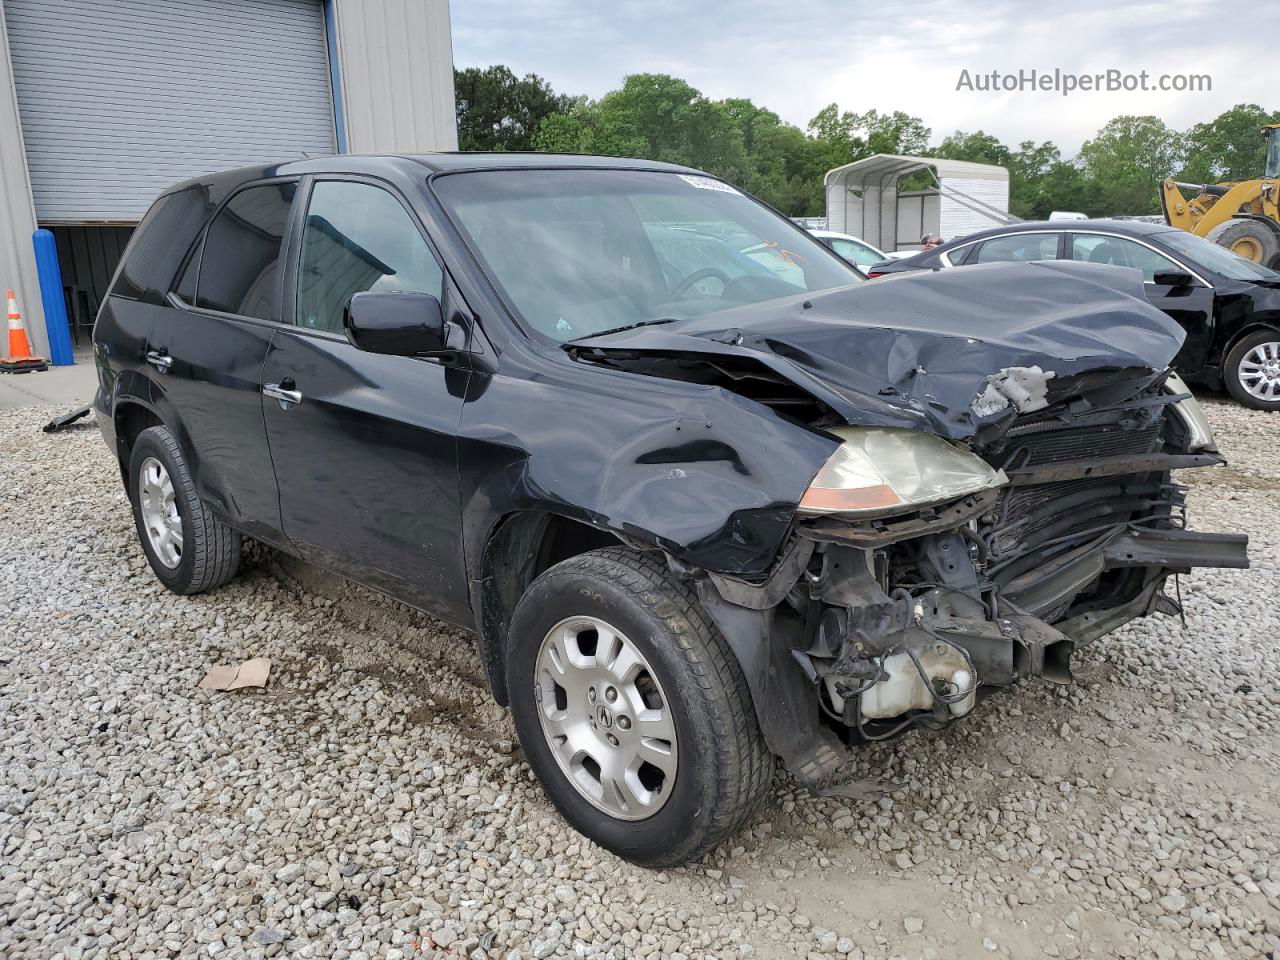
[434,170,863,342]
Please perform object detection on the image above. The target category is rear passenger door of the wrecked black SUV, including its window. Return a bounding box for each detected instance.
[145,180,298,543]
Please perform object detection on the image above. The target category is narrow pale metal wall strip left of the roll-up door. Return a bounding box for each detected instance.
[0,0,49,355]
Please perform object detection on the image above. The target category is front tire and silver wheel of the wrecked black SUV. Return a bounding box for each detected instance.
[507,548,774,867]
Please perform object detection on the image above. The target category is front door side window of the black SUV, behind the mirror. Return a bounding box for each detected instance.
[297,180,444,333]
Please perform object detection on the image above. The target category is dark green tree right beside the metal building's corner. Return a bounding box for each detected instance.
[453,64,572,150]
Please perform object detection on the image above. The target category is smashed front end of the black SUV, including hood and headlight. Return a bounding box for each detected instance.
[568,262,1248,792]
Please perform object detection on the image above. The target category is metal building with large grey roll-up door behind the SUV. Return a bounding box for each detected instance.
[0,0,457,356]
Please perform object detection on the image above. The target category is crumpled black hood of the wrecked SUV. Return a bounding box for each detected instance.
[567,261,1184,439]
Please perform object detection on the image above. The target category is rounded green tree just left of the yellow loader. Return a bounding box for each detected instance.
[1073,116,1184,215]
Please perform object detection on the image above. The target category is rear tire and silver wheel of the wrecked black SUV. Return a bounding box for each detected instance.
[128,426,241,594]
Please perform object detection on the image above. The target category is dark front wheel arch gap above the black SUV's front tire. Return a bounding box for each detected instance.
[471,509,636,707]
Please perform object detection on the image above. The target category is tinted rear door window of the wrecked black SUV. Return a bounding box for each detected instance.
[194,183,297,320]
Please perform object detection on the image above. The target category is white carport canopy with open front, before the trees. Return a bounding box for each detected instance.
[826,154,1016,251]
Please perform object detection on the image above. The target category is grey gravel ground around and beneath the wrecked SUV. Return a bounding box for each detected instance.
[0,402,1280,960]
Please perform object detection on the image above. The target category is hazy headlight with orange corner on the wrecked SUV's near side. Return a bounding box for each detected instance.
[800,426,1009,516]
